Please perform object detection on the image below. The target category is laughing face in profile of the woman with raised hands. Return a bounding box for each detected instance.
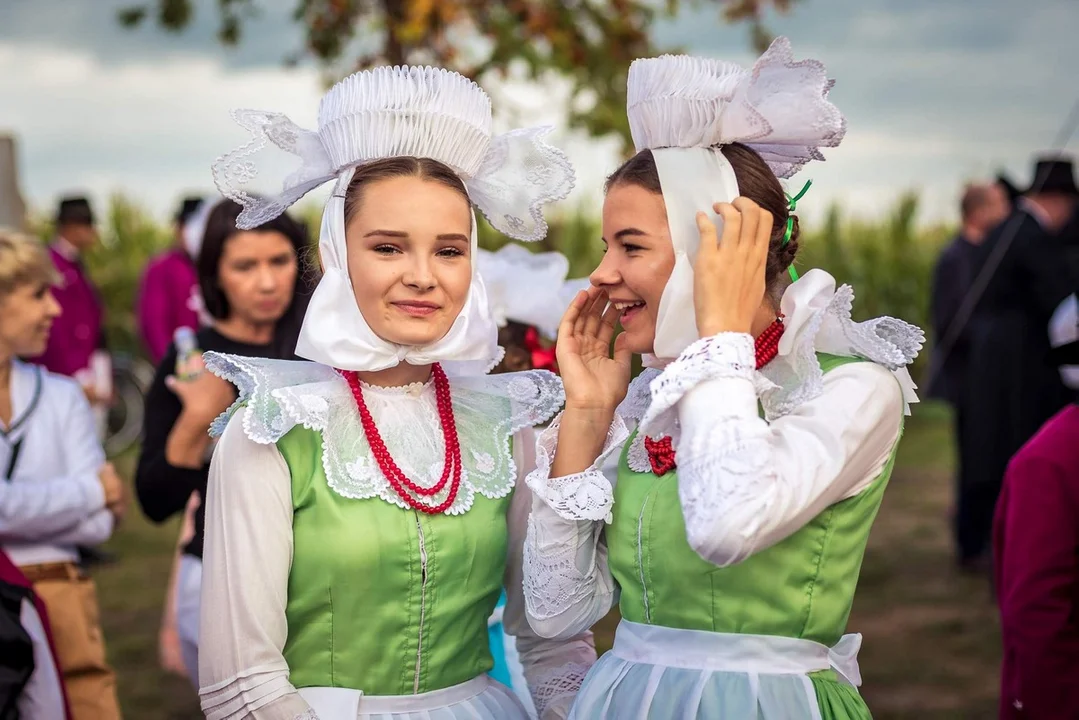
[590,184,674,353]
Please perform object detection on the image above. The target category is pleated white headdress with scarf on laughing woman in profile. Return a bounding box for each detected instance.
[627,38,846,366]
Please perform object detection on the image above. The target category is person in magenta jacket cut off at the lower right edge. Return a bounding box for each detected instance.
[993,342,1079,720]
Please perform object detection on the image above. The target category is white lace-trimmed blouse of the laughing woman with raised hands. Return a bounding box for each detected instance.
[524,271,921,637]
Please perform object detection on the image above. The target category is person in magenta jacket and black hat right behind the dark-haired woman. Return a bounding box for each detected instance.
[138,198,203,364]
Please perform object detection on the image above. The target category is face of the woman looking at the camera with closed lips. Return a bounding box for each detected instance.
[345,171,473,345]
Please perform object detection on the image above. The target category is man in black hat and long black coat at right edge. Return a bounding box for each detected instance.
[957,158,1079,566]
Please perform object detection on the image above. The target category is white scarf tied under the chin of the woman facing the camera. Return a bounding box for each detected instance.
[296,168,503,376]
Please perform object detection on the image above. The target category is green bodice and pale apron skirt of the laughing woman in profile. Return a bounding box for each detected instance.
[573,355,898,720]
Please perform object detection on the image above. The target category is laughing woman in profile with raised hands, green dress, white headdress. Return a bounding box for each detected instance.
[524,39,923,720]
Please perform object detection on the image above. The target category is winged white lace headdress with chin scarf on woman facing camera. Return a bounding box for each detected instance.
[214,67,574,375]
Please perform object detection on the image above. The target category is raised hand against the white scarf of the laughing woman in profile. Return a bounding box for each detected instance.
[693,198,773,338]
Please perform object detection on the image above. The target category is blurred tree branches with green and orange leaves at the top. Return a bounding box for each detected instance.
[119,0,796,147]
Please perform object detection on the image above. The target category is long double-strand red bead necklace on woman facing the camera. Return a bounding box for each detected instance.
[338,363,461,515]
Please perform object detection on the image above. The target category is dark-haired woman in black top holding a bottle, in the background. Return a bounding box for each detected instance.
[135,200,311,684]
